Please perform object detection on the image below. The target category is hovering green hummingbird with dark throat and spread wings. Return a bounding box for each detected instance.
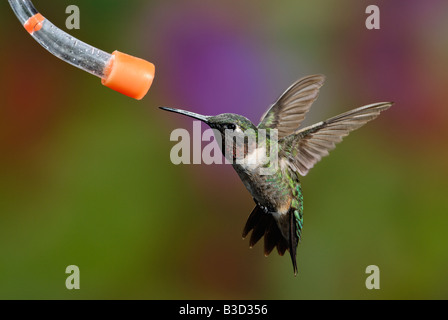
[160,75,393,275]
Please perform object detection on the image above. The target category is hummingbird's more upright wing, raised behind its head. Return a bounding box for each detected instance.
[258,75,325,139]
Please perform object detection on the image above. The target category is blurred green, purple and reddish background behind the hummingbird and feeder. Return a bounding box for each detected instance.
[0,0,448,299]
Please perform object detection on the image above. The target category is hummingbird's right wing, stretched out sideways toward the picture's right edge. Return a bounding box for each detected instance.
[280,102,393,176]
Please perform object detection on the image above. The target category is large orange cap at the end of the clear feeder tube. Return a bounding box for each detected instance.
[101,51,155,100]
